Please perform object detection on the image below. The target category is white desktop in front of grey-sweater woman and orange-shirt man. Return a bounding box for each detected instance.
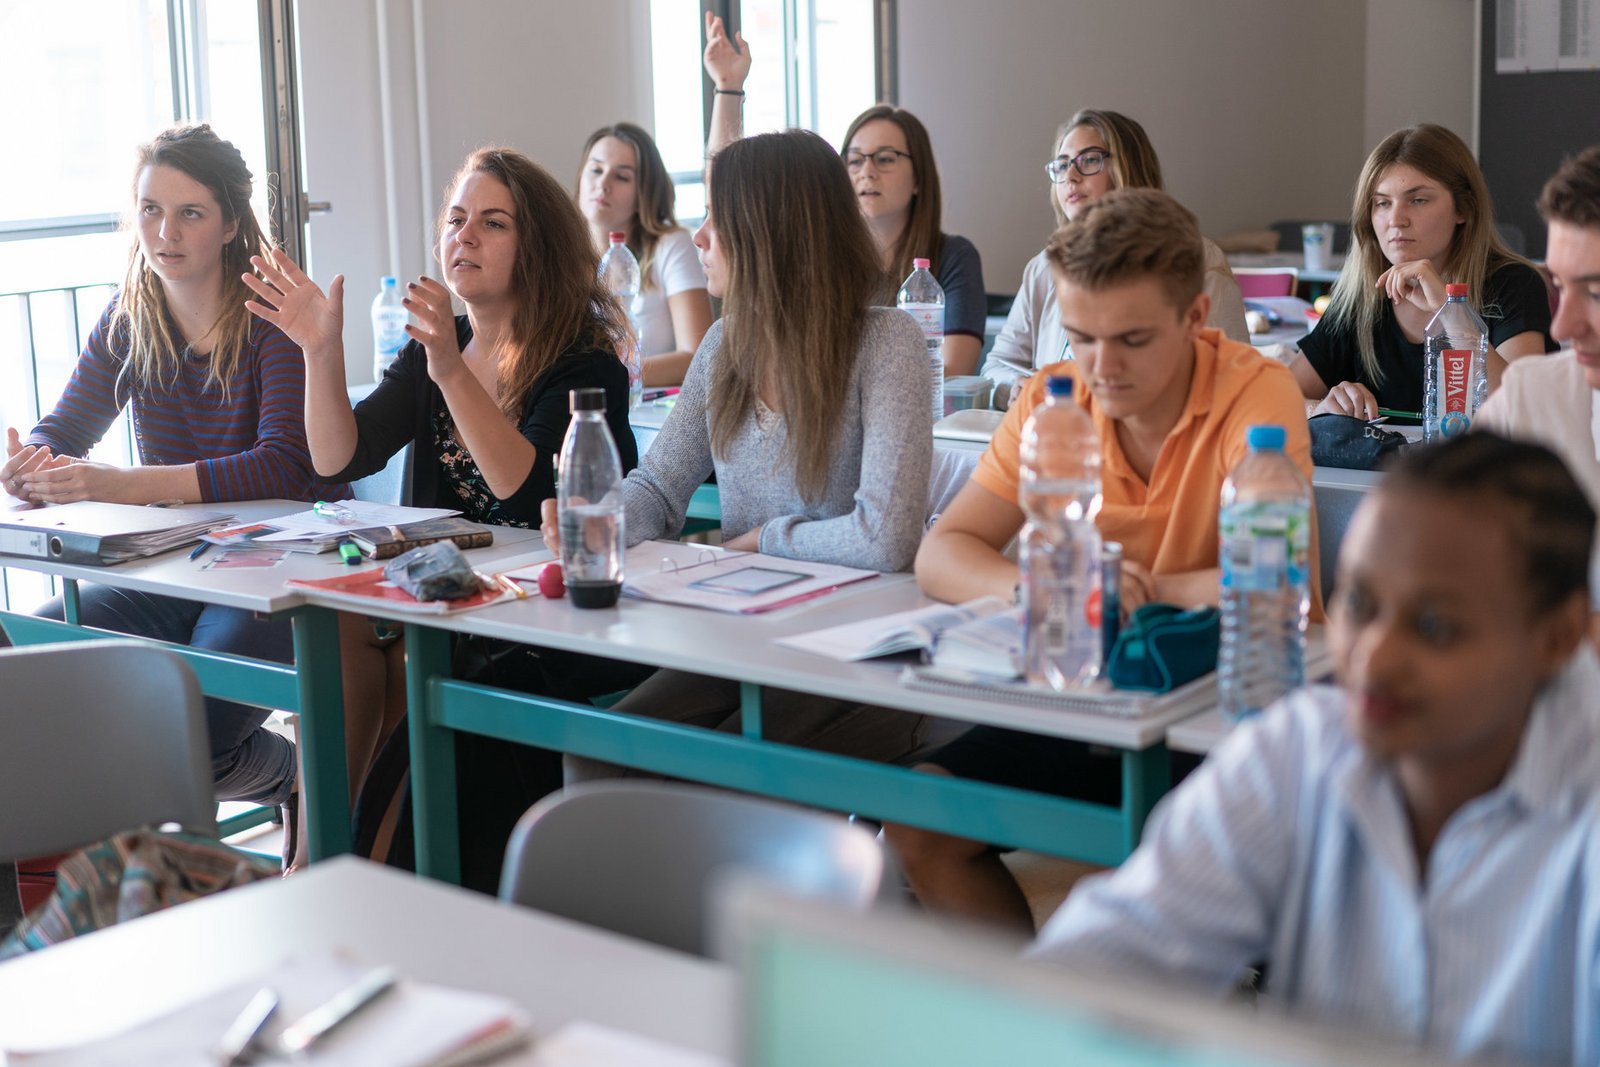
[300,550,1187,750]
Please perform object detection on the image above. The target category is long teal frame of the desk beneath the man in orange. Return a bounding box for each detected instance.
[396,619,1171,881]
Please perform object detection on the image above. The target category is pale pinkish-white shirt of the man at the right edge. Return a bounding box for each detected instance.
[1472,350,1600,611]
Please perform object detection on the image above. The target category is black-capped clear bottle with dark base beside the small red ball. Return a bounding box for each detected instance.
[555,389,624,608]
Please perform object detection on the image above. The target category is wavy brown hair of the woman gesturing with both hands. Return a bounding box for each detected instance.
[451,147,627,418]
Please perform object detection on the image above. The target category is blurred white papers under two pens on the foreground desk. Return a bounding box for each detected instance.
[3,955,528,1067]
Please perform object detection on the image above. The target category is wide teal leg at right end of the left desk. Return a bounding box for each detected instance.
[294,608,350,861]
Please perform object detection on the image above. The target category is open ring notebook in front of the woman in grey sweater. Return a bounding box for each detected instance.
[622,541,878,614]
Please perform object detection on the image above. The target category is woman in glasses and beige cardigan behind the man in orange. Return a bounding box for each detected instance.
[984,109,1250,406]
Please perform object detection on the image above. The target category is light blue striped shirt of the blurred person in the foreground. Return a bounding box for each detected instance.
[1032,645,1600,1065]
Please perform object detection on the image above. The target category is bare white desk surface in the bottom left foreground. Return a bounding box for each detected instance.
[0,857,734,1064]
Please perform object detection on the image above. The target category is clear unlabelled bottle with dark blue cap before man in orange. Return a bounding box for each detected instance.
[1018,378,1102,689]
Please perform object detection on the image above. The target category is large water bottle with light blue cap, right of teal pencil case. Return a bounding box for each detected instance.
[1216,426,1310,721]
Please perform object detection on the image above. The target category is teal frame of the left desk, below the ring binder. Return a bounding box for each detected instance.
[0,598,350,861]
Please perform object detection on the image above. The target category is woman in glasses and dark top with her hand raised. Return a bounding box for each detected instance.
[704,13,987,374]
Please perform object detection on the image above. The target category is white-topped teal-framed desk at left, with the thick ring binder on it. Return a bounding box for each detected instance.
[0,501,539,859]
